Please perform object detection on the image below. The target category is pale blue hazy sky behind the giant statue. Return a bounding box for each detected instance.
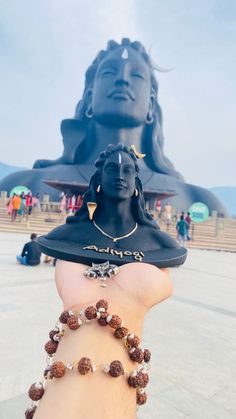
[0,0,236,187]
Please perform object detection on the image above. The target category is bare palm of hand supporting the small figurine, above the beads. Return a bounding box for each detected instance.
[56,261,172,313]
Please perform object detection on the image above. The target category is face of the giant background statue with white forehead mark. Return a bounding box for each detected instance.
[91,47,153,126]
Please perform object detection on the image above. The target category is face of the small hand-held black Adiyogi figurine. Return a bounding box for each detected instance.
[101,151,136,200]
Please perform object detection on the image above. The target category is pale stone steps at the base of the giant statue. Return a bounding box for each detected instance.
[0,207,236,252]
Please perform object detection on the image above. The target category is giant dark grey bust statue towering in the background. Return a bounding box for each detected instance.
[0,38,229,214]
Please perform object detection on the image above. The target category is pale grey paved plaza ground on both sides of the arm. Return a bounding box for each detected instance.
[0,233,236,419]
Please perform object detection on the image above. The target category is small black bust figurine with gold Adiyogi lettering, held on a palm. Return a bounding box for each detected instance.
[39,144,186,268]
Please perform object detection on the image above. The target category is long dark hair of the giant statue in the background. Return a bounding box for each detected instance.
[75,38,183,180]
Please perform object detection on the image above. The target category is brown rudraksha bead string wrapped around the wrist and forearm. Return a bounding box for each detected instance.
[25,299,151,419]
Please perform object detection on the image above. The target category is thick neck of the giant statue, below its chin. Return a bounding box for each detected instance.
[86,122,144,164]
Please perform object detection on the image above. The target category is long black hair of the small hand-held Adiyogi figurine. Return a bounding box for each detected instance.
[74,144,158,228]
